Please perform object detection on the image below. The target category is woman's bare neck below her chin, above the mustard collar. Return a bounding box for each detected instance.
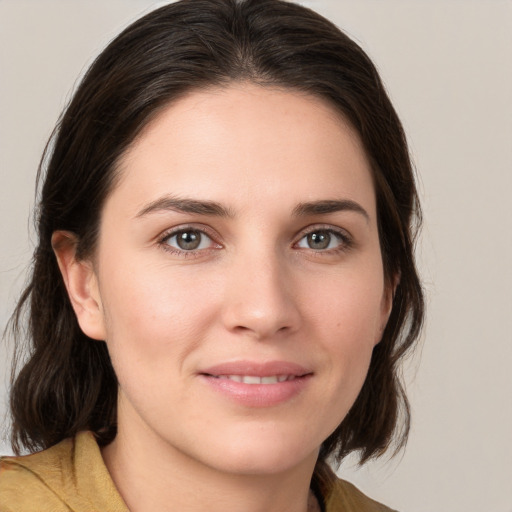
[102,425,319,512]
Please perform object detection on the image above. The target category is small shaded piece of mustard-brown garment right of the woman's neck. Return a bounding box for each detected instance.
[314,463,396,512]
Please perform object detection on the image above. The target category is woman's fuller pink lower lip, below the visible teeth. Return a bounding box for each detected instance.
[200,374,313,407]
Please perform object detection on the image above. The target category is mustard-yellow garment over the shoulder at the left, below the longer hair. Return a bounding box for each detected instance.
[0,432,126,512]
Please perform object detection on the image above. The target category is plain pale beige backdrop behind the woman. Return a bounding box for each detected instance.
[0,0,512,512]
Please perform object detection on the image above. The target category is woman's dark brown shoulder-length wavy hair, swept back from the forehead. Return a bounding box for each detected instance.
[10,0,424,463]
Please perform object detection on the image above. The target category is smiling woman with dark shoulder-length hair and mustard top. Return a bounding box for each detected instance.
[0,0,423,512]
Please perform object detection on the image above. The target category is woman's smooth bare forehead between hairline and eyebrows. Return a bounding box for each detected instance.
[112,84,374,218]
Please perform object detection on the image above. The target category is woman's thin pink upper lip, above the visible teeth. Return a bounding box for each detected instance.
[199,361,312,377]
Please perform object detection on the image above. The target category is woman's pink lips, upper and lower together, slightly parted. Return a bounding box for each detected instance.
[198,361,313,407]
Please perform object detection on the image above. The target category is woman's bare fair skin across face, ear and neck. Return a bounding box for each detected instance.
[54,84,392,512]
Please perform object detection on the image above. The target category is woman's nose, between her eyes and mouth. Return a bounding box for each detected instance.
[222,250,301,340]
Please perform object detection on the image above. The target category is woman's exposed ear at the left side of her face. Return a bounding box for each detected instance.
[52,231,106,340]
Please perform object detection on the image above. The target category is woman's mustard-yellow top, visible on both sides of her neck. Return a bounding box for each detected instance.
[0,432,392,512]
